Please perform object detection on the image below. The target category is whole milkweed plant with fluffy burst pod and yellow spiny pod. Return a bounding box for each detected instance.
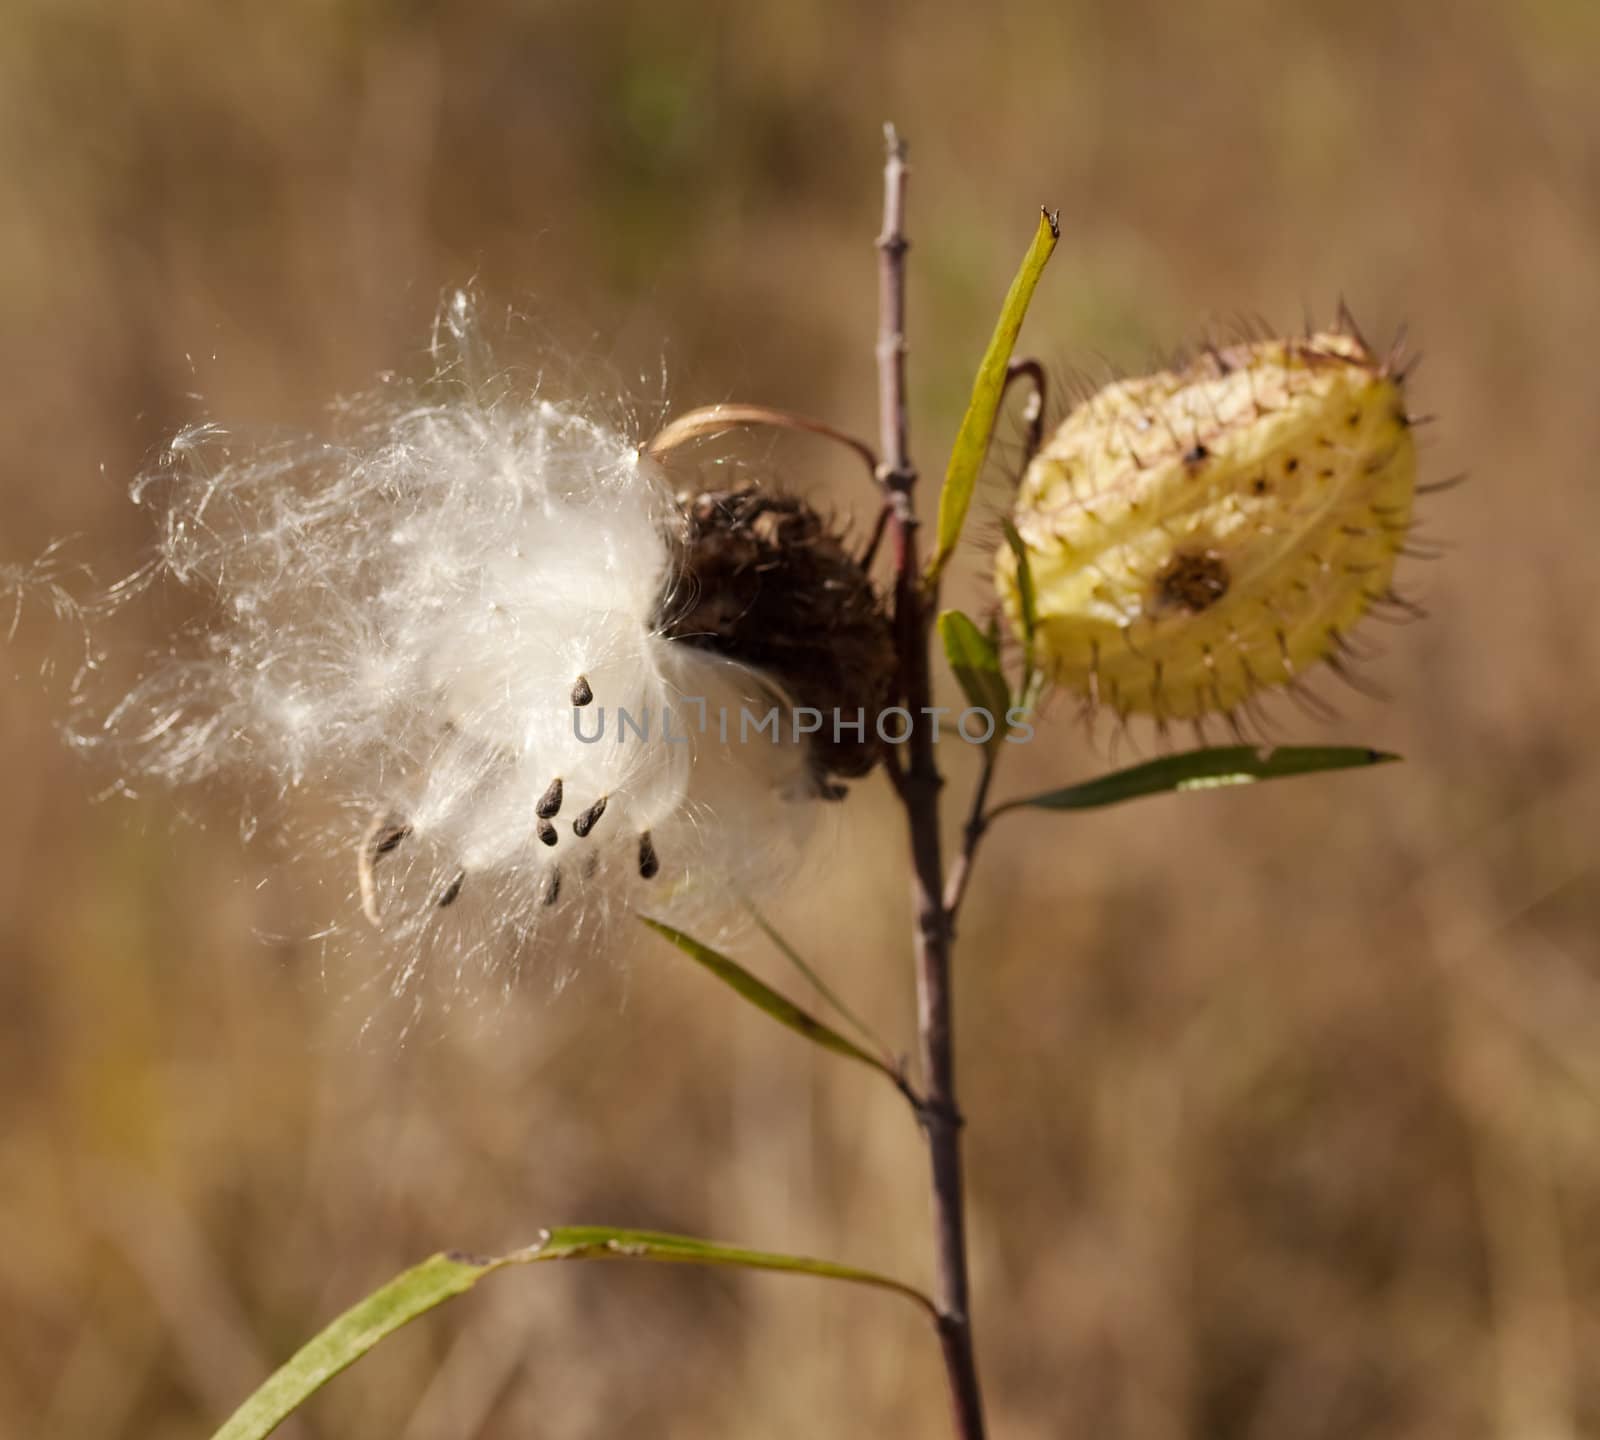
[43,130,1446,1440]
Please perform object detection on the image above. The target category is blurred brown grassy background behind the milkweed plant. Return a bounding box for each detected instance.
[0,0,1600,1440]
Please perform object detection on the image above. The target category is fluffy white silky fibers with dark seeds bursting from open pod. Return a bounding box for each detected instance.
[78,301,814,992]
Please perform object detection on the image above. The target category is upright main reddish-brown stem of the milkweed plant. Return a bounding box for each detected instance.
[877,126,984,1440]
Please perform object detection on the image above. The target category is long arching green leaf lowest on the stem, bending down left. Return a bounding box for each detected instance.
[213,1226,938,1440]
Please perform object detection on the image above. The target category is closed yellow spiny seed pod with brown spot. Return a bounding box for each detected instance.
[997,333,1416,720]
